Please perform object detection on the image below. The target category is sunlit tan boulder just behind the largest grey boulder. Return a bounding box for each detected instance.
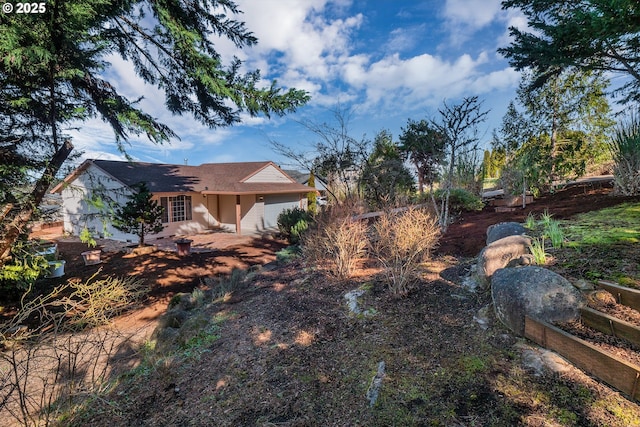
[475,236,531,290]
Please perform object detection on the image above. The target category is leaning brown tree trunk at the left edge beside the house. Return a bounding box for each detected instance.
[0,140,73,260]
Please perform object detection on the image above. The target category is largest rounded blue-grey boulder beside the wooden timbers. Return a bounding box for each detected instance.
[491,266,583,336]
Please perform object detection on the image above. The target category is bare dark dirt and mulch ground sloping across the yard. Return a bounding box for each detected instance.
[7,183,640,427]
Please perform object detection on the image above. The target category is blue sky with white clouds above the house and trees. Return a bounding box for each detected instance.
[66,0,526,171]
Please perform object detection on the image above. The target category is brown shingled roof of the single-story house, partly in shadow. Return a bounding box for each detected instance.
[52,160,309,194]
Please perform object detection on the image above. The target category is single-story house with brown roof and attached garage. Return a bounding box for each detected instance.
[51,160,310,241]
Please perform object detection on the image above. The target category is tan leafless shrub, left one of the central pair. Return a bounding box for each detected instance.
[302,214,368,280]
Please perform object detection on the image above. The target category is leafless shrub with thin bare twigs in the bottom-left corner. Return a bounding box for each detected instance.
[0,276,148,426]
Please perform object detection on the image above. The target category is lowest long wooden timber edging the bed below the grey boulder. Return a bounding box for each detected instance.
[524,316,640,401]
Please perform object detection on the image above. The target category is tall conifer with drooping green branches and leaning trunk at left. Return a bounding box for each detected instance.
[0,0,309,264]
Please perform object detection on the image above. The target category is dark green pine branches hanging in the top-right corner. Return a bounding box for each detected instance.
[498,0,640,102]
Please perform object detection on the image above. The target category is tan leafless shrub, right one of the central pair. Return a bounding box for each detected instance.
[370,208,440,296]
